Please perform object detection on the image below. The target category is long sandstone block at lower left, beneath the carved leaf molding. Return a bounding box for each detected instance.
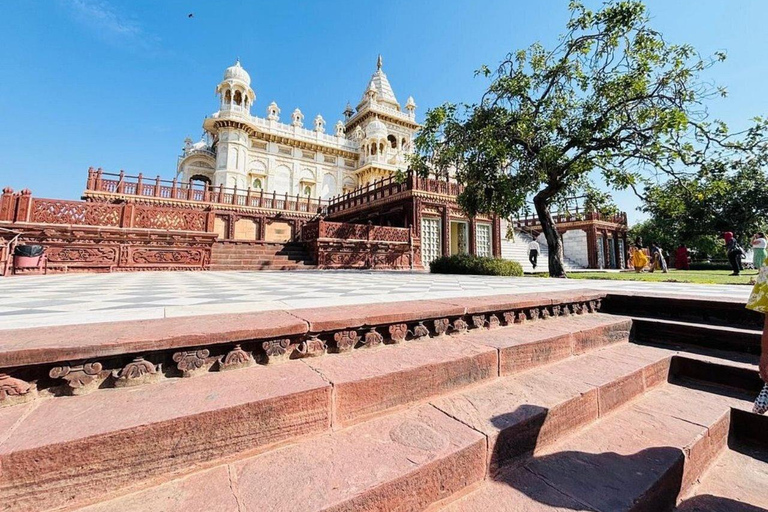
[0,361,331,510]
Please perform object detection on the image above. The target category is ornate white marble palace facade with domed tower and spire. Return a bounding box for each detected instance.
[178,56,419,199]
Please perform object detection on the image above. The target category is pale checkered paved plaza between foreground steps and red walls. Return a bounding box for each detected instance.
[0,271,751,329]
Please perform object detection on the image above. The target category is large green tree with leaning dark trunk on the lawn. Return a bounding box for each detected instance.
[412,0,762,277]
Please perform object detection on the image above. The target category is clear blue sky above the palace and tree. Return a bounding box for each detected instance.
[0,0,768,224]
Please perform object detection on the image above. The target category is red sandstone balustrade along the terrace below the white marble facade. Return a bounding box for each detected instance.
[84,168,327,213]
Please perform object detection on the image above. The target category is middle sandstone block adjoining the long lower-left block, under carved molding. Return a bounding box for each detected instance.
[307,337,498,426]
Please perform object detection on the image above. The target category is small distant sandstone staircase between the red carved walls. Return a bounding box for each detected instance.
[210,242,316,270]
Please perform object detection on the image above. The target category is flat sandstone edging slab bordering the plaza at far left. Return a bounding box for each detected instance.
[0,311,307,368]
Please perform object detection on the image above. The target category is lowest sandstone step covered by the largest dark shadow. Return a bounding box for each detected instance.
[442,384,752,512]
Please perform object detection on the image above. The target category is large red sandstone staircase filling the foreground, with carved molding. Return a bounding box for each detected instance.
[0,291,768,512]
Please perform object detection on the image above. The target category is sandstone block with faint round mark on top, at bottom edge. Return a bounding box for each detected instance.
[235,405,485,512]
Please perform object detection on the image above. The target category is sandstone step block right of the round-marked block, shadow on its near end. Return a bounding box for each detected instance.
[432,343,672,472]
